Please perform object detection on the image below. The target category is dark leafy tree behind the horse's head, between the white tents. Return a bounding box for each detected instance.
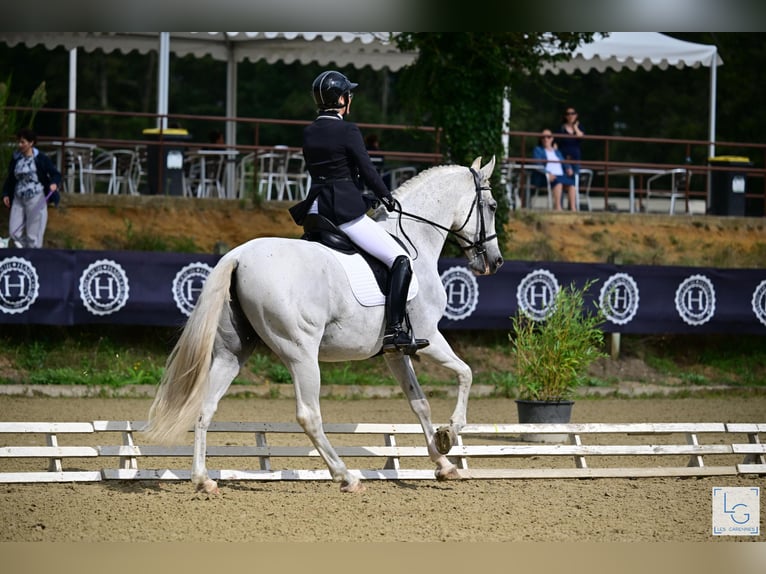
[396,32,593,247]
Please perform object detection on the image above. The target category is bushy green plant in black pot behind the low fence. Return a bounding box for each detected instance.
[511,281,605,442]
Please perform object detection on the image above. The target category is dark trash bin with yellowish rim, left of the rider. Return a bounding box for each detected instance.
[143,128,189,195]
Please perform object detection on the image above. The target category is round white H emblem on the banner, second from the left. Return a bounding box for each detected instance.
[80,259,130,315]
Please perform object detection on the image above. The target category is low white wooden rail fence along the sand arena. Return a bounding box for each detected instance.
[0,421,766,483]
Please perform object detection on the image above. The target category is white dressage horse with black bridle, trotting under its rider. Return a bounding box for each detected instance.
[146,158,503,493]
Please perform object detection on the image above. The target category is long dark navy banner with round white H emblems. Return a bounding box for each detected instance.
[0,249,766,335]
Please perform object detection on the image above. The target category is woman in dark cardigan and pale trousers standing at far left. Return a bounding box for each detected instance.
[3,128,61,248]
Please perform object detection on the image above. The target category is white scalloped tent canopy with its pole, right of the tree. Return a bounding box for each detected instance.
[542,32,723,157]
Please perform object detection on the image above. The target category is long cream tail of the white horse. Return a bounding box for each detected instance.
[145,254,238,443]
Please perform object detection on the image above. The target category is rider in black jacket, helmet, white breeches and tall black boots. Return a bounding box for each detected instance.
[290,70,429,355]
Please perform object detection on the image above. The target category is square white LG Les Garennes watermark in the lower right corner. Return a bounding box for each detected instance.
[713,486,761,536]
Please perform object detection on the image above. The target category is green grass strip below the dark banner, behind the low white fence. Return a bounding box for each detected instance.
[0,325,766,396]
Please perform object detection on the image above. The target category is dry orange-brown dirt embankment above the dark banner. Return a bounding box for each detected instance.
[46,195,766,267]
